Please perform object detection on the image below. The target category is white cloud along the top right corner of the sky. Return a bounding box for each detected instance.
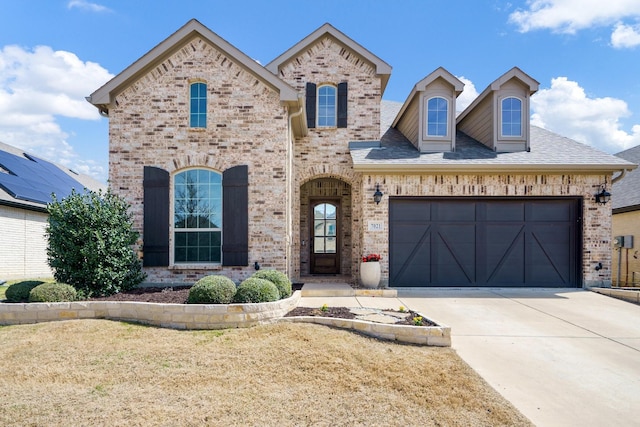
[509,0,640,34]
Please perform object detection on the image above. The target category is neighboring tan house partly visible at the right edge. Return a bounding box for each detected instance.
[611,145,640,287]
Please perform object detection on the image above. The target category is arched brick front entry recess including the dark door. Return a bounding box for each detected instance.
[300,178,352,275]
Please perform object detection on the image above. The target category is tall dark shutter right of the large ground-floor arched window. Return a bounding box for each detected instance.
[222,165,249,266]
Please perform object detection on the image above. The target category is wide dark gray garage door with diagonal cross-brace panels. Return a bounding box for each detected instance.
[389,198,581,287]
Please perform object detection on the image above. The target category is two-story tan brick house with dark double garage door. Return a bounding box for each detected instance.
[88,20,635,287]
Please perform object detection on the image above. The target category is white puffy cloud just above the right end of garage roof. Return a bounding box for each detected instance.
[531,77,640,153]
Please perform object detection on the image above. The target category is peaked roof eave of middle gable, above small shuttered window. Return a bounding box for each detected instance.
[265,22,391,93]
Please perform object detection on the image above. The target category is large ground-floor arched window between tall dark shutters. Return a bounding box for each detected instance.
[173,169,222,263]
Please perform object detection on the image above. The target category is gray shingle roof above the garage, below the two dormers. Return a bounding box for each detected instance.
[351,126,634,172]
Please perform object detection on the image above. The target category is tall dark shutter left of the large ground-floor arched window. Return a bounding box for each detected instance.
[142,166,170,267]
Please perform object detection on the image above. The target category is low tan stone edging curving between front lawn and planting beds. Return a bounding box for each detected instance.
[0,291,451,347]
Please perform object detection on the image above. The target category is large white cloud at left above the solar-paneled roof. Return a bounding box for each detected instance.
[0,46,113,181]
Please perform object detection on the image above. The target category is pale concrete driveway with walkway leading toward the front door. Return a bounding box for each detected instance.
[300,289,640,426]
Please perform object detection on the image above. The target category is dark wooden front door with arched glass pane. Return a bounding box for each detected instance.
[310,201,340,274]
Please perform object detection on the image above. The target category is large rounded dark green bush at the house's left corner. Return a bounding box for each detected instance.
[47,190,145,297]
